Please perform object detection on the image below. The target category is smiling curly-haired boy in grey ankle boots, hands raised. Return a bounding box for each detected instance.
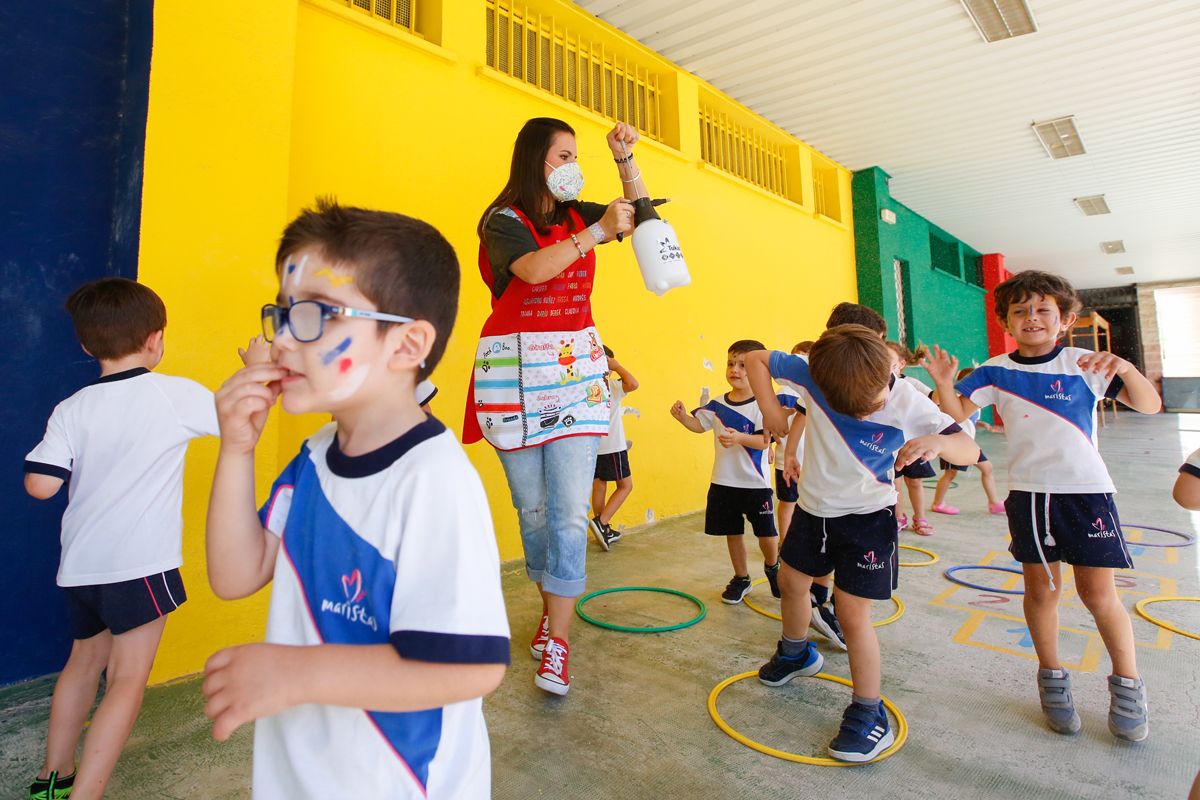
[922,270,1162,741]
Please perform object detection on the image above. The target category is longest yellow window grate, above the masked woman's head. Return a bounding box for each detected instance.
[480,0,662,142]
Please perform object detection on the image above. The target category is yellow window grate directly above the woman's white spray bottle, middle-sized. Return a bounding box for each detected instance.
[700,94,800,201]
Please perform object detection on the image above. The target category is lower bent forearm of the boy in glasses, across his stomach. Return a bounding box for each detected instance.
[202,644,505,741]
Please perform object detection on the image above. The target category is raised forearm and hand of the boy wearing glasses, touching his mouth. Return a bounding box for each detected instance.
[204,363,286,600]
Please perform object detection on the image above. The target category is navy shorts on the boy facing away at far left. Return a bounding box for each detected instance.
[62,570,187,639]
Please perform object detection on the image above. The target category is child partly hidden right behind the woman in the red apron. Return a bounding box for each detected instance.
[589,344,637,551]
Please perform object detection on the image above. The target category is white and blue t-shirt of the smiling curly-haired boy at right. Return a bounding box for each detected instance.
[955,347,1124,494]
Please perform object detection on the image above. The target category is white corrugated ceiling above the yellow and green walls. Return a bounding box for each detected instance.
[576,0,1200,288]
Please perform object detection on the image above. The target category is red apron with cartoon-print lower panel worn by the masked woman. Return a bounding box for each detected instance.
[462,209,610,450]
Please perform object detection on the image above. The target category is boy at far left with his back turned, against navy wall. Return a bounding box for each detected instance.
[25,278,217,800]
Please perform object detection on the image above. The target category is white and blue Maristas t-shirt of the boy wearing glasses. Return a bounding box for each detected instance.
[253,417,509,800]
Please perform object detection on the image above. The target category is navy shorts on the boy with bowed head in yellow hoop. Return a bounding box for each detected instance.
[779,506,900,600]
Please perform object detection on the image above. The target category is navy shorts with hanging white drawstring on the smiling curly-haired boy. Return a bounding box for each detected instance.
[1004,492,1133,570]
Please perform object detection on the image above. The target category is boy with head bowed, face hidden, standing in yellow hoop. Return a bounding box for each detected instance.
[746,325,979,763]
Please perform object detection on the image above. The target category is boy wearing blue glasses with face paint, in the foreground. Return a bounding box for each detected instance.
[203,201,509,800]
